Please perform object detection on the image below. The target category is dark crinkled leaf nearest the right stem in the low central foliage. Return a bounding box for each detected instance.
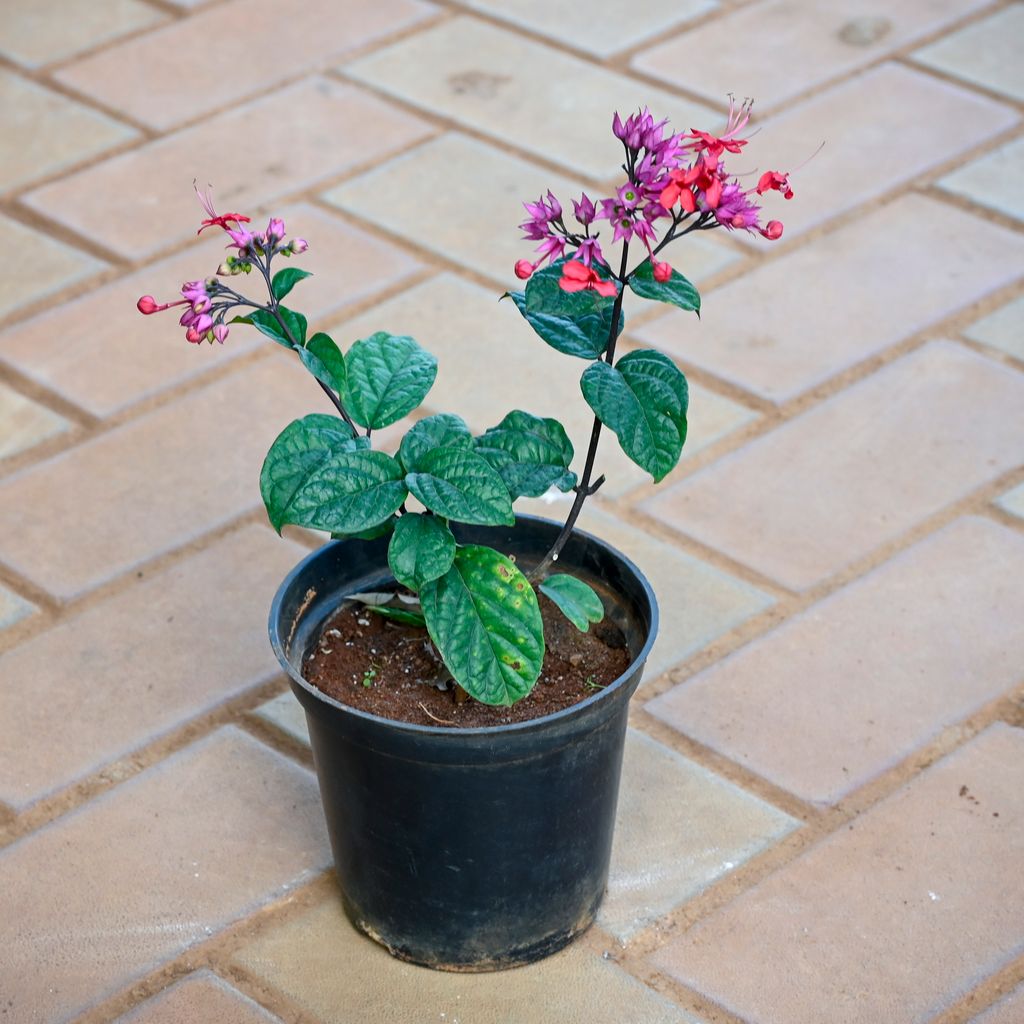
[476,409,577,501]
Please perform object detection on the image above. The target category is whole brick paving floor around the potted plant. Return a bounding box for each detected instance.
[0,0,1024,1024]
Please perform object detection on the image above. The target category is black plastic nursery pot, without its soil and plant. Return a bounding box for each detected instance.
[270,516,657,971]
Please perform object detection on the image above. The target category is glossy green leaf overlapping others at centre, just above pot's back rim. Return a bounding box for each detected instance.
[406,447,515,526]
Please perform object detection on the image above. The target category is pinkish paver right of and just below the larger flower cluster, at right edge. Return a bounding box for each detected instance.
[633,196,1024,401]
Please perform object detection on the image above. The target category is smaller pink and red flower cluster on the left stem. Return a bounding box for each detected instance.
[136,187,308,345]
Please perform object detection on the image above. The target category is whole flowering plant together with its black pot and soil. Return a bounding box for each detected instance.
[138,103,792,971]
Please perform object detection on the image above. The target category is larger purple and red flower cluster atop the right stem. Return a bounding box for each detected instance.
[515,98,793,291]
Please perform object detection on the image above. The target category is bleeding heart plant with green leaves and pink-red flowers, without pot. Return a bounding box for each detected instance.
[138,102,793,705]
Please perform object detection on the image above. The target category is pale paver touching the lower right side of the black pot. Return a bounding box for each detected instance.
[598,730,799,941]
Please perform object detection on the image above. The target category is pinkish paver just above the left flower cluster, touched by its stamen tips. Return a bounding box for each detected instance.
[26,80,427,259]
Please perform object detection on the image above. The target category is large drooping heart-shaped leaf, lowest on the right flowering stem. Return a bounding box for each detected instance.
[580,349,689,483]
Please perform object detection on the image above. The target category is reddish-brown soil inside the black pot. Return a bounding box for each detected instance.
[303,596,630,728]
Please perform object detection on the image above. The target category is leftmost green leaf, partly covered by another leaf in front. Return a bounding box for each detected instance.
[259,413,366,534]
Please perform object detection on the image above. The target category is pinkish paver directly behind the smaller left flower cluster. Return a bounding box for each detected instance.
[0,203,419,417]
